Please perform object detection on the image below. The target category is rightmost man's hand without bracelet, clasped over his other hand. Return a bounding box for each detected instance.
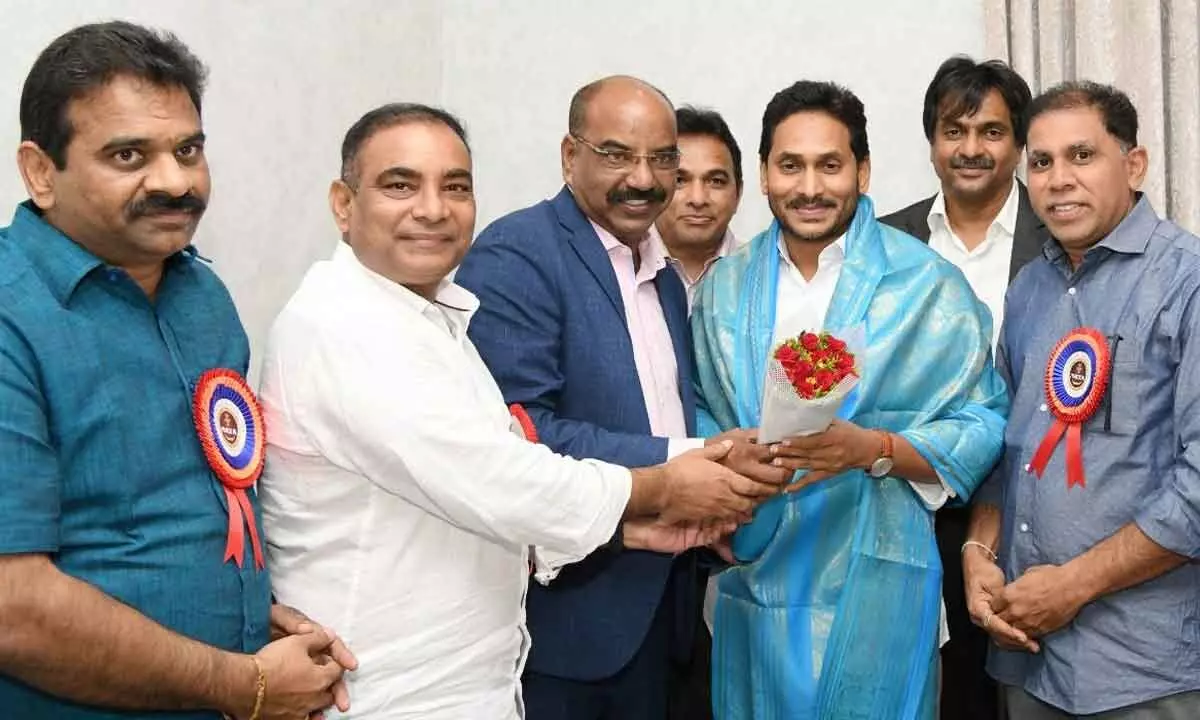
[992,565,1087,637]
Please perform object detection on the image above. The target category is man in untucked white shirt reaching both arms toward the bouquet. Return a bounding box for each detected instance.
[260,104,778,720]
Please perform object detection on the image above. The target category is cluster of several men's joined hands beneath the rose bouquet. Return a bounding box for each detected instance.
[623,420,880,562]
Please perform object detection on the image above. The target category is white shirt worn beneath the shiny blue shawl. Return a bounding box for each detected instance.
[772,235,954,644]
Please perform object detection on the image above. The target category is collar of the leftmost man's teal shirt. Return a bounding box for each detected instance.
[8,200,206,306]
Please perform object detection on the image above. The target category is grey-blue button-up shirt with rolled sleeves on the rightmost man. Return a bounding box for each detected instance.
[976,198,1200,714]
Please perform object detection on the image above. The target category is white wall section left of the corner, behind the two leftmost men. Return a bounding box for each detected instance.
[0,0,442,366]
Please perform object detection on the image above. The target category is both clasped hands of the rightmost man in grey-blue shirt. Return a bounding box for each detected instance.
[962,546,1088,653]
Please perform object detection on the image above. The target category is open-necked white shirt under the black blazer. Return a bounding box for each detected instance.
[929,180,1020,350]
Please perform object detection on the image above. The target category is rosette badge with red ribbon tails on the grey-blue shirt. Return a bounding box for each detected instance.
[1030,328,1112,487]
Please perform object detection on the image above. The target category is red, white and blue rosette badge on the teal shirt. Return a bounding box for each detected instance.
[192,368,266,570]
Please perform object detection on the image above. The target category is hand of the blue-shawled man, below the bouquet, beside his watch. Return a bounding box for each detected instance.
[770,420,882,492]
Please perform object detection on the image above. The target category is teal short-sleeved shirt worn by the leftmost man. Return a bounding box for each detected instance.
[0,203,270,720]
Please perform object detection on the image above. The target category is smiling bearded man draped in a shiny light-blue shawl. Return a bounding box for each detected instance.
[692,80,1008,720]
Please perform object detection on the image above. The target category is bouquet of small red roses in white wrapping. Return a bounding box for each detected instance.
[758,331,859,443]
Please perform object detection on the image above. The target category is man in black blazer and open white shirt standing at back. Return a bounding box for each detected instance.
[880,56,1050,720]
